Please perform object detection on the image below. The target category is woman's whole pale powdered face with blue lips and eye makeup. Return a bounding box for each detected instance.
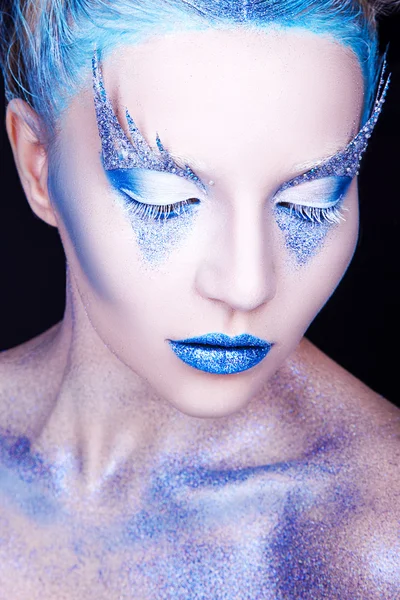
[49,30,363,417]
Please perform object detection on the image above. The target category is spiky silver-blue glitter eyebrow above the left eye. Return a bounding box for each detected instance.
[92,52,207,193]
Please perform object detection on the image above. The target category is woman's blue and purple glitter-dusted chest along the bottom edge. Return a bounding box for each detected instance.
[0,484,373,600]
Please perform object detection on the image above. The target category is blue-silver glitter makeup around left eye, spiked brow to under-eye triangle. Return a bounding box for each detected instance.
[92,53,207,267]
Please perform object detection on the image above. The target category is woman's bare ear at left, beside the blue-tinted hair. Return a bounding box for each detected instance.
[6,98,57,227]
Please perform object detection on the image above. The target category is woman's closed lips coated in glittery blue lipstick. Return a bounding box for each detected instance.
[168,333,272,375]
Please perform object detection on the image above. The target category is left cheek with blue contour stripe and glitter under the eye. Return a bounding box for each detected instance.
[49,159,202,352]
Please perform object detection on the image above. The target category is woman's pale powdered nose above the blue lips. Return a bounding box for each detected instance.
[196,202,276,311]
